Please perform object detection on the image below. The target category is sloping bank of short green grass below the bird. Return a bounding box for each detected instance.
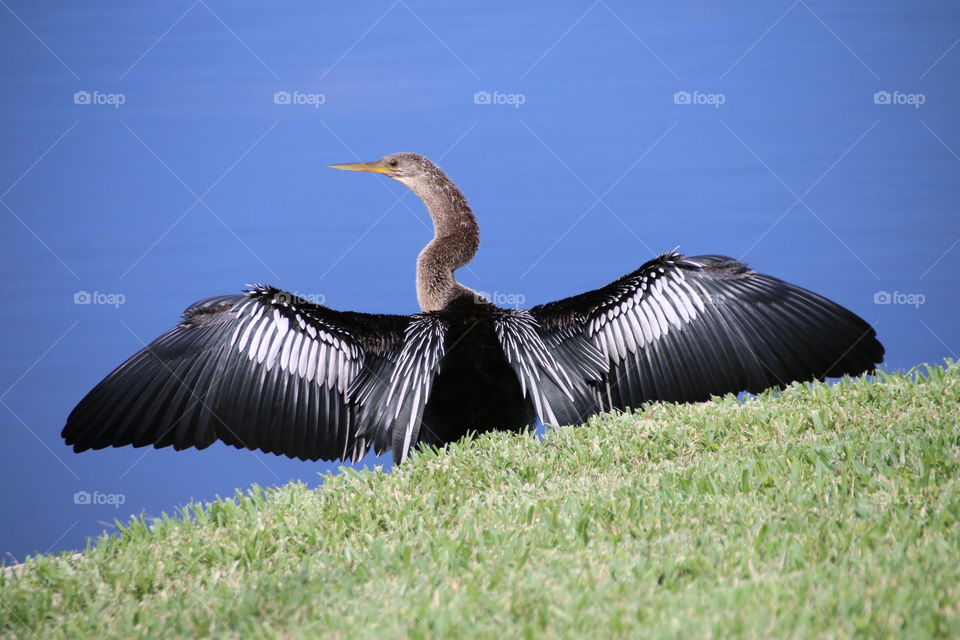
[0,364,960,638]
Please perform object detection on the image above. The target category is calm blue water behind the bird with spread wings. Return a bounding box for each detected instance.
[0,0,960,561]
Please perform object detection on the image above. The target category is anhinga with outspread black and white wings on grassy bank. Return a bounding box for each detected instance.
[62,152,884,464]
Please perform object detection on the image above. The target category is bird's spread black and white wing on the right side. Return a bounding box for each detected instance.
[530,253,884,419]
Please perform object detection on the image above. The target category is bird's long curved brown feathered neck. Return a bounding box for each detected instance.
[403,169,480,311]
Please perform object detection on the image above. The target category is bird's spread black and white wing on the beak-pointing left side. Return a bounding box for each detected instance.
[62,285,442,460]
